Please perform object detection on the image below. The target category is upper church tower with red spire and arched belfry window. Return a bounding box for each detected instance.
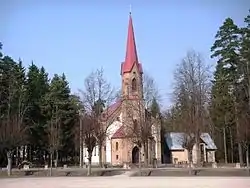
[121,12,143,100]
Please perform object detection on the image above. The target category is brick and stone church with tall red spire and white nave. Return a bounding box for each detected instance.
[83,13,161,166]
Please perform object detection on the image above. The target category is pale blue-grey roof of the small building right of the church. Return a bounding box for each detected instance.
[164,132,217,150]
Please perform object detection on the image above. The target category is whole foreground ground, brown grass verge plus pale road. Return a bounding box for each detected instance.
[0,168,250,188]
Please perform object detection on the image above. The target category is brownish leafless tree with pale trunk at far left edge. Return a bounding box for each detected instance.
[0,83,28,176]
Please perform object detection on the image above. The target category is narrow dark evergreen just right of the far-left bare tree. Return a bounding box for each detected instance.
[26,62,48,161]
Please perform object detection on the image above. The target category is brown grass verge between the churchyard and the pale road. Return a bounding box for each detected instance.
[0,168,250,179]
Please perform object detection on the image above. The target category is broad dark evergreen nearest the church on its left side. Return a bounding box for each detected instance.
[43,74,77,167]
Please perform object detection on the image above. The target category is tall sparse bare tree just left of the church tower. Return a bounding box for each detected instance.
[81,69,115,167]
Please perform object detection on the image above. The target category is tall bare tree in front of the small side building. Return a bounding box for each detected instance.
[174,51,211,170]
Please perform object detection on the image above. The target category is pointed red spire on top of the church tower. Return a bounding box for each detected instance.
[121,13,142,74]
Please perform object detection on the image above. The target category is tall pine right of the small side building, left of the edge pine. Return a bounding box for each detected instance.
[211,18,243,164]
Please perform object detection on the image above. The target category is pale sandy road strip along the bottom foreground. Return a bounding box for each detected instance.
[0,177,250,188]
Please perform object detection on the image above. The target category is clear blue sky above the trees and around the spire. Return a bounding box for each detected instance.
[0,0,250,106]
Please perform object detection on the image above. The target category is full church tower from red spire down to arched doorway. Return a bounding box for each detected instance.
[121,12,145,163]
